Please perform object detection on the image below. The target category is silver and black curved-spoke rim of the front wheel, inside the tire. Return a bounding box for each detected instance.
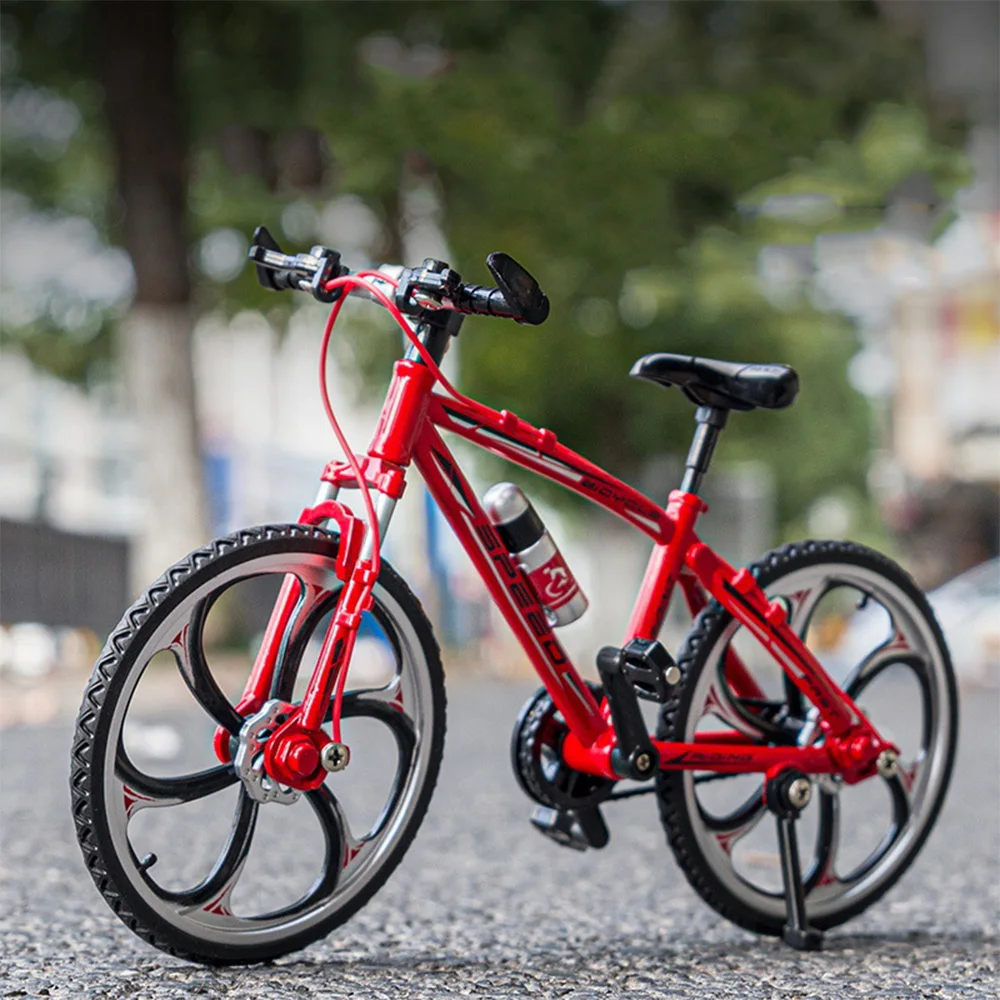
[94,552,437,951]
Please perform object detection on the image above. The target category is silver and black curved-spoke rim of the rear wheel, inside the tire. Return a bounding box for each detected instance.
[681,562,955,926]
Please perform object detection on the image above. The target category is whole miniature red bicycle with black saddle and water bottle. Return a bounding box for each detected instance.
[72,227,957,963]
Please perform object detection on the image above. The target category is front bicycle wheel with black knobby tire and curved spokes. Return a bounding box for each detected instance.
[71,525,445,964]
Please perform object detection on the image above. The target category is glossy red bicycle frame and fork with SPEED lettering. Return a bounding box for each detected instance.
[225,360,892,787]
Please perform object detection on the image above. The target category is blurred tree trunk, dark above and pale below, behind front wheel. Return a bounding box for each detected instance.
[96,0,209,587]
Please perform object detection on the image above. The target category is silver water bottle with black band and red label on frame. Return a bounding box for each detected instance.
[483,483,588,628]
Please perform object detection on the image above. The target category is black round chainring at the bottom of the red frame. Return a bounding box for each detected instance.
[510,684,615,809]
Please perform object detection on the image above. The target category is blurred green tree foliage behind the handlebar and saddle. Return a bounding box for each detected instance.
[0,0,967,530]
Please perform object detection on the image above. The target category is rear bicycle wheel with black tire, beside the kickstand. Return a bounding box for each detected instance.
[657,541,958,934]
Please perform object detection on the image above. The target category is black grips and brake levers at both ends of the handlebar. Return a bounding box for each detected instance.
[248,226,549,325]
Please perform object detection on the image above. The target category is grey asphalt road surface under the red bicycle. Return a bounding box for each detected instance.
[0,679,1000,1000]
